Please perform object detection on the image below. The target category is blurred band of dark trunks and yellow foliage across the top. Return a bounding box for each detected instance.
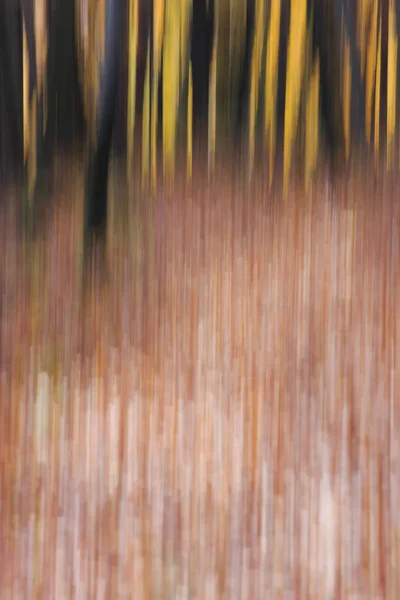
[0,0,400,191]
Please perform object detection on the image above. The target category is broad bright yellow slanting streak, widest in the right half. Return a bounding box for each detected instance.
[283,0,307,189]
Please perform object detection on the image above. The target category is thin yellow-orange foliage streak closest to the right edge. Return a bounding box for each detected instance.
[386,0,398,169]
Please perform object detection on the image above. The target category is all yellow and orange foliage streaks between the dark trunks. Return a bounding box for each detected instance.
[23,0,398,190]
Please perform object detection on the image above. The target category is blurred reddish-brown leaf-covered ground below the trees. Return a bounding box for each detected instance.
[0,152,400,600]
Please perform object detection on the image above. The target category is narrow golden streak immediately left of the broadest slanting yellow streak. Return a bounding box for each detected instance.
[265,0,281,185]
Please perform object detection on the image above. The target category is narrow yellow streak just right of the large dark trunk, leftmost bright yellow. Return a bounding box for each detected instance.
[127,0,138,182]
